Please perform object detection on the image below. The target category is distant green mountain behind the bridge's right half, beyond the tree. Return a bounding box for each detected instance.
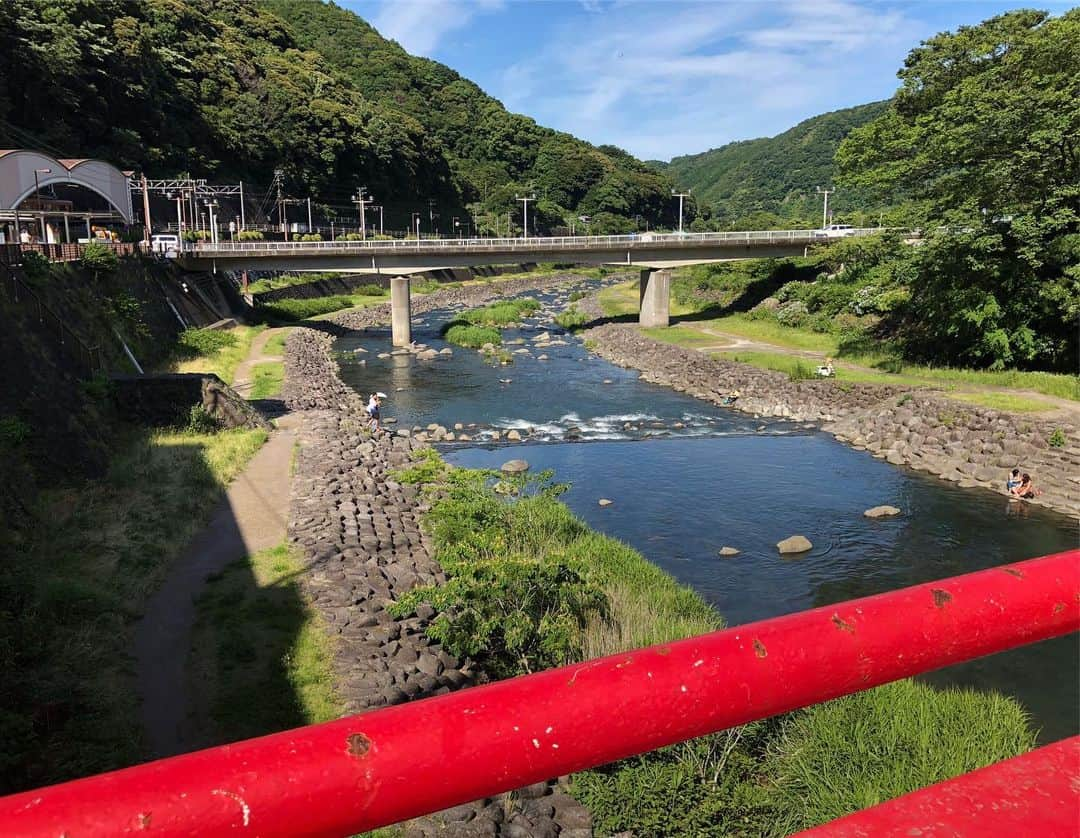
[659,102,888,225]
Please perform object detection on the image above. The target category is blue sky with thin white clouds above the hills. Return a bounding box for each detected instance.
[338,0,1071,160]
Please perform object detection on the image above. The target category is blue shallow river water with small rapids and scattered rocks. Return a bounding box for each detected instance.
[336,280,1080,741]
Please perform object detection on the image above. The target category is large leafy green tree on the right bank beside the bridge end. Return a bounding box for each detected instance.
[836,10,1080,369]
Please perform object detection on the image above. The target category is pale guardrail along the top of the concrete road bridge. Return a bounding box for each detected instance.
[184,227,886,256]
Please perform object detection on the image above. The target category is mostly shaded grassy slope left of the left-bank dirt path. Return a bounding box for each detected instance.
[0,431,267,790]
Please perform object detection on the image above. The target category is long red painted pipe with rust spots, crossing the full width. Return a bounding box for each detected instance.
[0,551,1080,838]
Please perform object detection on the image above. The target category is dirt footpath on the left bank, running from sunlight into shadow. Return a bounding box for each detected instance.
[135,333,301,757]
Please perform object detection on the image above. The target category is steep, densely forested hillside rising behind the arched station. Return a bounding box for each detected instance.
[0,0,671,229]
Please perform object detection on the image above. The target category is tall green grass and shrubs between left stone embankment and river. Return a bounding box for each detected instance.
[396,452,1034,836]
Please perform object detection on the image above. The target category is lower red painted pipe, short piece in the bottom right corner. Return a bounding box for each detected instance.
[793,736,1080,838]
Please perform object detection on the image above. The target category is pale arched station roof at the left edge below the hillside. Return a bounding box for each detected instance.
[0,149,133,224]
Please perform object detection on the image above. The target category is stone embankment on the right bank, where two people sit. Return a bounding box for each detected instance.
[584,323,1080,515]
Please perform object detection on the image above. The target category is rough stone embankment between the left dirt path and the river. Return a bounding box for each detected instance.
[283,275,592,838]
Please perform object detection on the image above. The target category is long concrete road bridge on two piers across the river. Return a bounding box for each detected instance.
[177,228,881,346]
